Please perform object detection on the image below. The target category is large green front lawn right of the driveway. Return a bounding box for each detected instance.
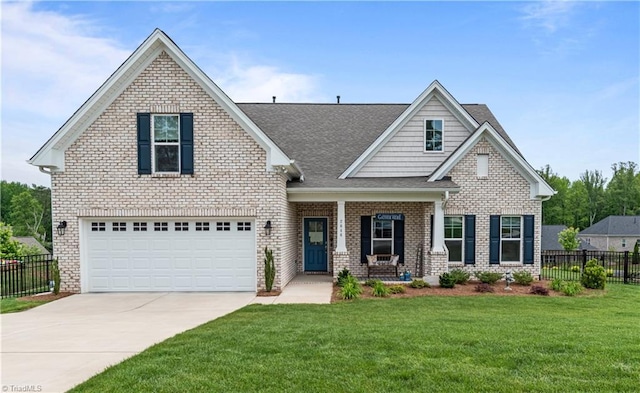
[72,285,640,393]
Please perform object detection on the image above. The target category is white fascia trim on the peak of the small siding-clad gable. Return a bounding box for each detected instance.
[339,80,479,179]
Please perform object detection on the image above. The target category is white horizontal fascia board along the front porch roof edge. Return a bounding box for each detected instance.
[287,188,460,202]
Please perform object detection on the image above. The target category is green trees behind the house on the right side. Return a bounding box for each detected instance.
[538,161,640,229]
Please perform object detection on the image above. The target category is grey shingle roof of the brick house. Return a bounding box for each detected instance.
[237,103,515,188]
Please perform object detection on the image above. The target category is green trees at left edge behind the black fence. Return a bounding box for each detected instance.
[0,180,52,250]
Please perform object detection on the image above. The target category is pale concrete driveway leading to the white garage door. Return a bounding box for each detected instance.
[0,293,256,392]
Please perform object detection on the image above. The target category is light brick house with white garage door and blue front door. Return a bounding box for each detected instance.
[30,30,554,292]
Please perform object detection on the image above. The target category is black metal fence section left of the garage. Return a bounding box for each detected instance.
[0,254,53,298]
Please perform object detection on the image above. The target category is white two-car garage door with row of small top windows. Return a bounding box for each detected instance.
[83,218,256,292]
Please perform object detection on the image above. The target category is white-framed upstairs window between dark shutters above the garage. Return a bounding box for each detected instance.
[151,115,180,173]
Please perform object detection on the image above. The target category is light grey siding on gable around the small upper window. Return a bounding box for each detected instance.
[354,97,470,177]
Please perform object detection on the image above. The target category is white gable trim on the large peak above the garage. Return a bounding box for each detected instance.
[28,29,296,172]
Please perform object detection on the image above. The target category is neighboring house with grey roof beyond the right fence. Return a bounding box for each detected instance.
[578,216,640,251]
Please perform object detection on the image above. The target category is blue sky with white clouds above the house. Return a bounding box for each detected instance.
[0,1,640,186]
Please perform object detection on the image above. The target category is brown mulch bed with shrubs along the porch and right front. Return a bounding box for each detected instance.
[331,280,564,303]
